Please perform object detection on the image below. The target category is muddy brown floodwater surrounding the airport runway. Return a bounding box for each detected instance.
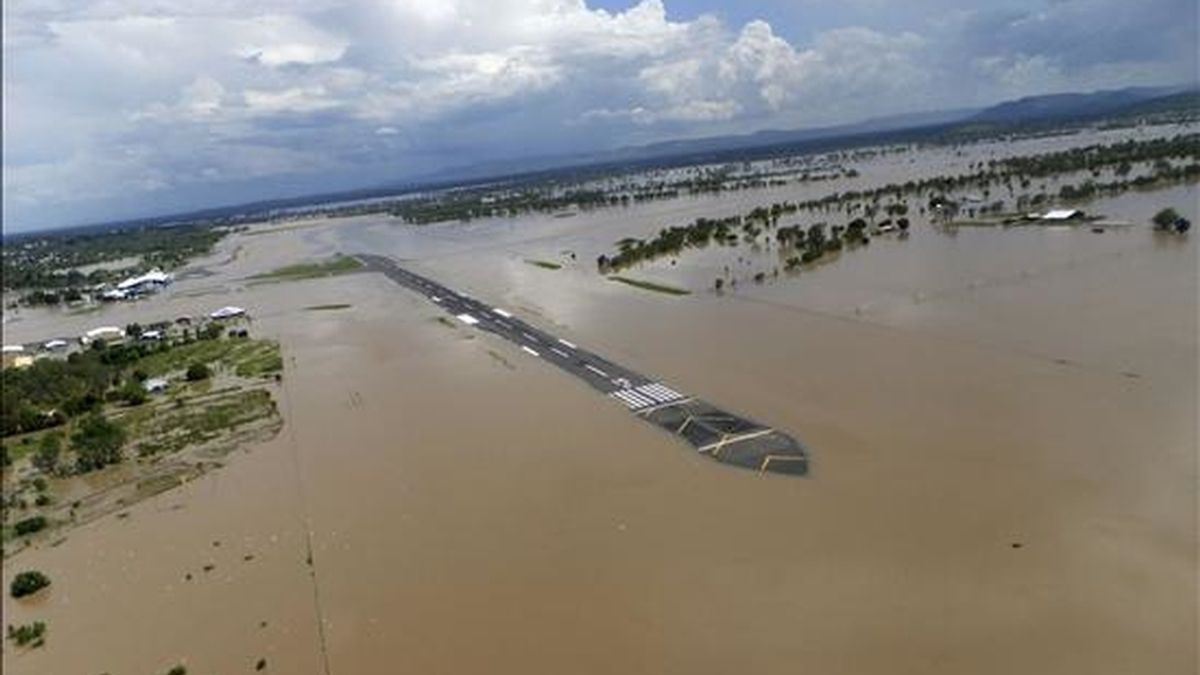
[4,128,1198,675]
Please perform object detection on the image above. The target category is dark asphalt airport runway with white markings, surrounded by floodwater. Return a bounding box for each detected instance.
[355,253,809,476]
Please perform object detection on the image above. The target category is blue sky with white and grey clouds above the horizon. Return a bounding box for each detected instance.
[2,0,1198,232]
